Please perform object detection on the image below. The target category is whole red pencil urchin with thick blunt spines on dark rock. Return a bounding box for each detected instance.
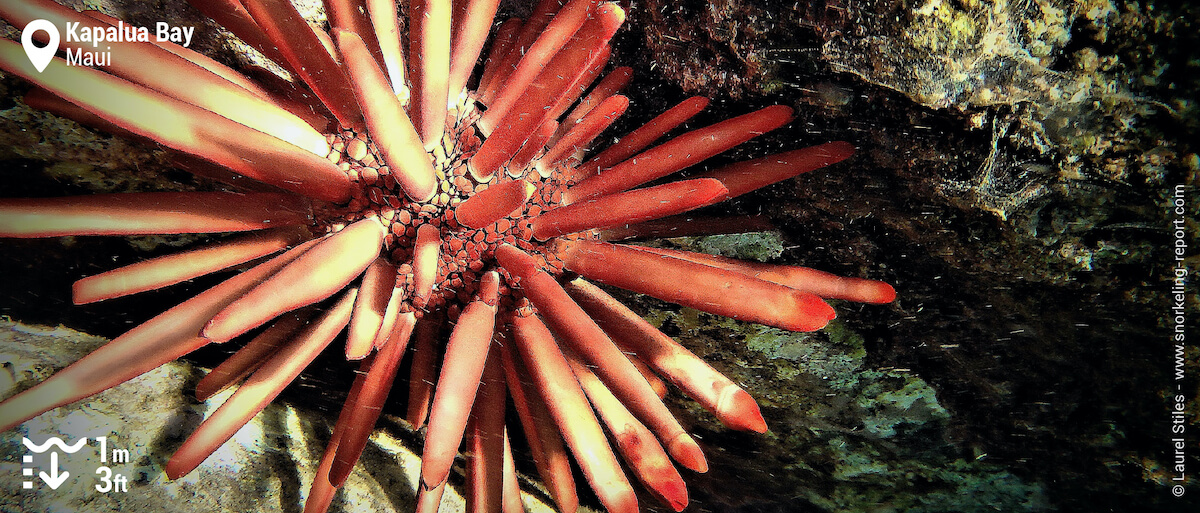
[0,0,894,512]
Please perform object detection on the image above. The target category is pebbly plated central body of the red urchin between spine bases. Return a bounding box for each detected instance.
[312,95,580,316]
